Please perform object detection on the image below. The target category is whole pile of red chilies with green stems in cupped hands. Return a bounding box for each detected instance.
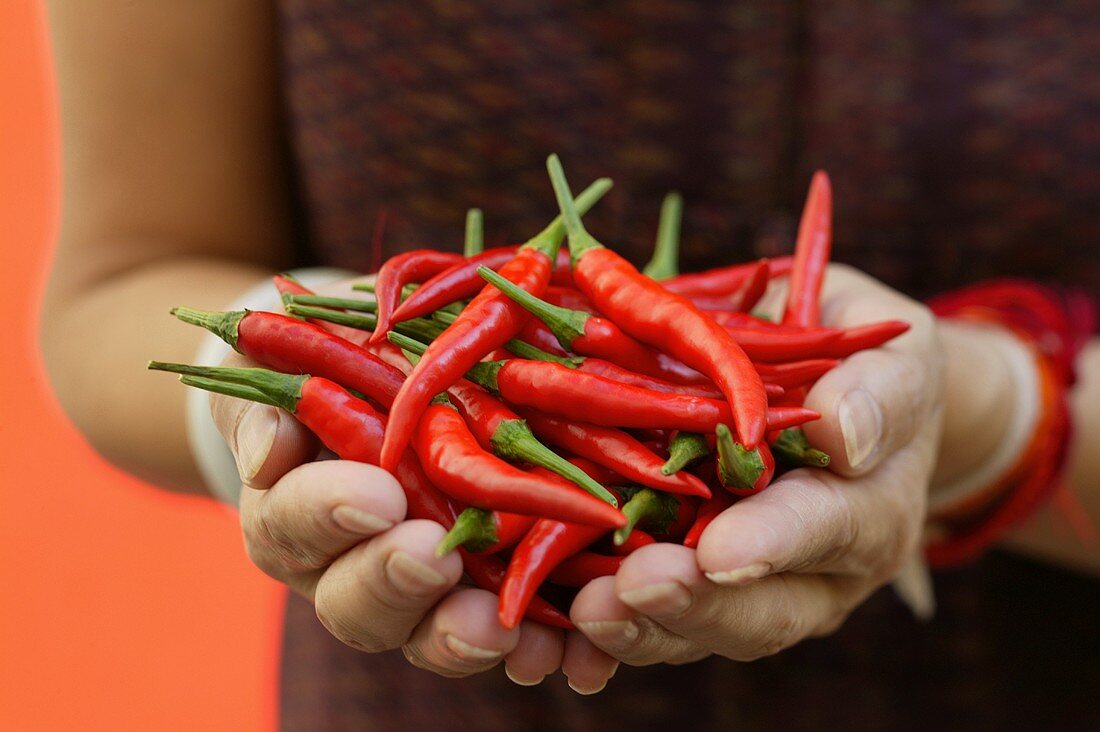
[150,156,908,627]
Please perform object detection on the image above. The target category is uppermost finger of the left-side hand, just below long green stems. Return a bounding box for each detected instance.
[210,353,320,489]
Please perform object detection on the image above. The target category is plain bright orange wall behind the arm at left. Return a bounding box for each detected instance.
[0,0,282,730]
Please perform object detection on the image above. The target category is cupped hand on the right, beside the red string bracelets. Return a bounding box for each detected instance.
[571,266,944,665]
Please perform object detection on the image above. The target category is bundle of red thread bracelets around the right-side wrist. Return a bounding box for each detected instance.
[925,280,1096,567]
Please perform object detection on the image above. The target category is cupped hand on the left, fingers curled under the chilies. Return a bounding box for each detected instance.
[210,275,565,684]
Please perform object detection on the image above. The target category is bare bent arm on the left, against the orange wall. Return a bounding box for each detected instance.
[42,0,290,491]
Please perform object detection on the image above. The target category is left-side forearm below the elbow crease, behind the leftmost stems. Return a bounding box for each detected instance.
[42,258,271,492]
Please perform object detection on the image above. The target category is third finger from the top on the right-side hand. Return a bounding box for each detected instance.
[615,544,853,660]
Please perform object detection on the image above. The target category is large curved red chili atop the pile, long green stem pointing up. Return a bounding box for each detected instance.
[547,155,768,449]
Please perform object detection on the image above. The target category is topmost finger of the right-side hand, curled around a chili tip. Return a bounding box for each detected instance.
[804,266,943,476]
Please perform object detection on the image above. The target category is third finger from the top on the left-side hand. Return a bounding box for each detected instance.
[314,521,462,652]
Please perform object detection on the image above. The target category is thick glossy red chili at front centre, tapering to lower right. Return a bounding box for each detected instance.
[411,404,626,531]
